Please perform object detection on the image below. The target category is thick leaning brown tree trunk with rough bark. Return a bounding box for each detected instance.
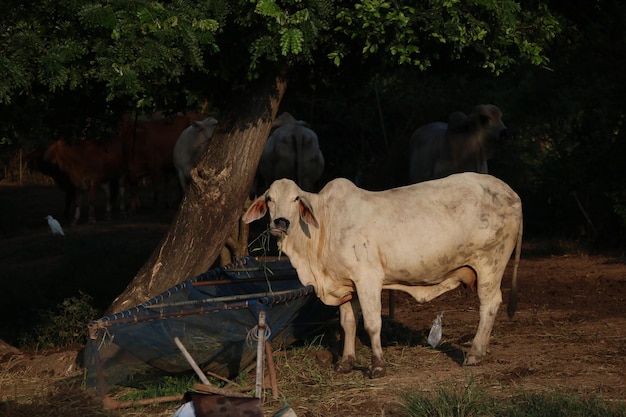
[108,78,287,313]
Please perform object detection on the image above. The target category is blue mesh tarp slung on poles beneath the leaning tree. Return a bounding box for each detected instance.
[86,258,337,385]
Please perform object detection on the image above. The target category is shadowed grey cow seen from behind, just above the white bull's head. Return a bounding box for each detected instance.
[252,112,324,195]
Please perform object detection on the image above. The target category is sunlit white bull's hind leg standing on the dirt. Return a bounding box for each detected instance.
[464,264,506,365]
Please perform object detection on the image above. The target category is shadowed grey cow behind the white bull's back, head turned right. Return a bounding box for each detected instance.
[409,104,510,183]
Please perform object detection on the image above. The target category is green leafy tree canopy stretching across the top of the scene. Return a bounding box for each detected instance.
[0,0,559,142]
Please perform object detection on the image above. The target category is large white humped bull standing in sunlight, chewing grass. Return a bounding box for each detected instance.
[243,173,522,378]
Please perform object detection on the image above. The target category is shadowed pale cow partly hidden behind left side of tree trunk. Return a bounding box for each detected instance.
[174,117,217,191]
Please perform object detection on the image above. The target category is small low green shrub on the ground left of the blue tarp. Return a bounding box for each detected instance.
[20,291,101,349]
